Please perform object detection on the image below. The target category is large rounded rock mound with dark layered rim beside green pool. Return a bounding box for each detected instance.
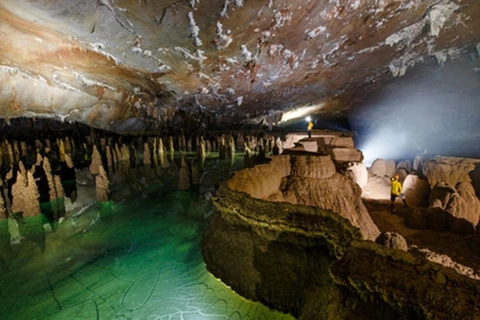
[202,149,480,319]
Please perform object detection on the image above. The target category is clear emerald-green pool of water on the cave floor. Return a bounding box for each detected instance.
[0,158,293,320]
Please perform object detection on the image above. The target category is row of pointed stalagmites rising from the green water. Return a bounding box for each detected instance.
[0,130,278,217]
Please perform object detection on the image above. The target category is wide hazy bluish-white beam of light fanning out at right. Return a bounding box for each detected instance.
[350,60,480,166]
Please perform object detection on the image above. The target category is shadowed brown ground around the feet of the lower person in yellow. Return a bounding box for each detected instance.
[363,199,480,275]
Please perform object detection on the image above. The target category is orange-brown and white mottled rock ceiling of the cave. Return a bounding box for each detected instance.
[0,0,480,131]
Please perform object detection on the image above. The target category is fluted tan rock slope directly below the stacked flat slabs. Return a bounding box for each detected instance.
[283,173,380,241]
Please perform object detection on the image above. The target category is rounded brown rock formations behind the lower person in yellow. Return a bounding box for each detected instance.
[369,155,480,235]
